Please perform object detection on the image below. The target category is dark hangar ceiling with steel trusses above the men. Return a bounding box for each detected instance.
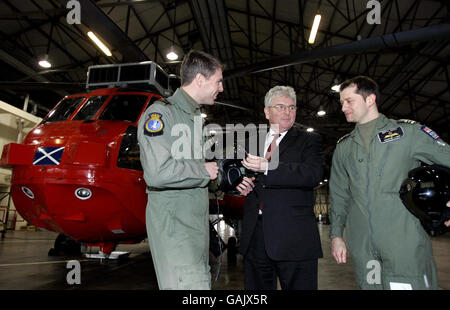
[0,0,450,172]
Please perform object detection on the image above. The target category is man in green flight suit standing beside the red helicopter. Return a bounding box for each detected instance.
[138,50,223,289]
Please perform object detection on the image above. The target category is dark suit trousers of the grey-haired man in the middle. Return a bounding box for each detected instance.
[244,216,317,290]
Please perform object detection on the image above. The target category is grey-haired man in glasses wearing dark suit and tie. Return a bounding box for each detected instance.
[237,86,323,290]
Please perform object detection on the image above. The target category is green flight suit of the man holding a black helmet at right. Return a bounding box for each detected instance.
[329,114,450,289]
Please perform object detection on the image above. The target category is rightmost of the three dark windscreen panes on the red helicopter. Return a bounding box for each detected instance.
[98,95,148,122]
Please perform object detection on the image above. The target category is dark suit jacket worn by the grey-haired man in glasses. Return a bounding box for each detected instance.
[240,128,323,261]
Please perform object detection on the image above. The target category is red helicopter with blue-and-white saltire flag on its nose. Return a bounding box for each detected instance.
[0,61,243,255]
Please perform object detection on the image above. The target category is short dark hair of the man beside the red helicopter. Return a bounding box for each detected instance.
[180,50,224,86]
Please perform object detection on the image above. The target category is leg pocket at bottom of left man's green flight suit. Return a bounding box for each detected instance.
[175,265,211,290]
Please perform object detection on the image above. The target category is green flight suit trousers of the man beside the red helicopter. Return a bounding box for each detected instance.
[146,199,211,290]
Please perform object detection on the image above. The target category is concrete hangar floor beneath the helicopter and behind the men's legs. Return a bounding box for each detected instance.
[0,222,450,290]
